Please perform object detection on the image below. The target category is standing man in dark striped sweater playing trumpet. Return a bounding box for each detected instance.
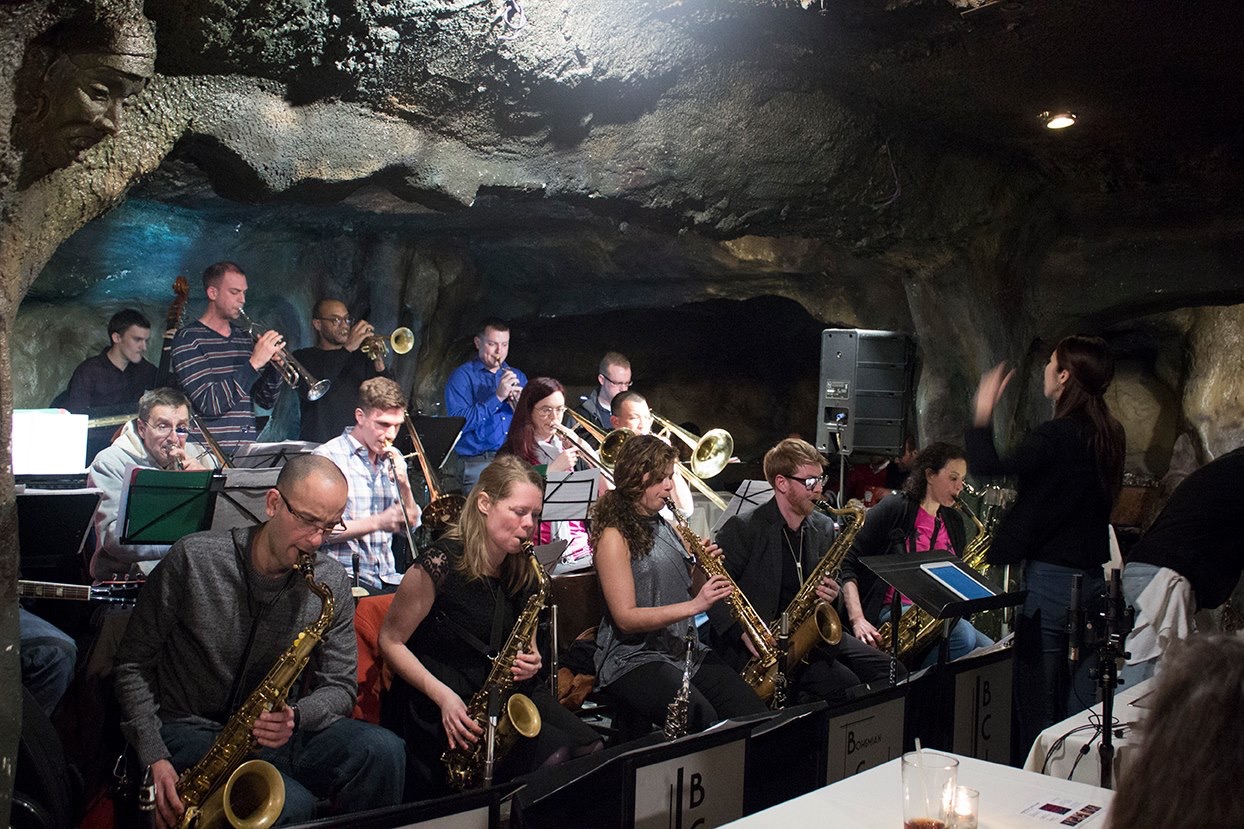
[172,261,285,454]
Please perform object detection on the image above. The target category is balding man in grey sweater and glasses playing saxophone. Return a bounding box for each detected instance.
[114,454,406,827]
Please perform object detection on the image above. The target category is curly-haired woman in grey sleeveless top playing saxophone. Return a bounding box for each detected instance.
[592,434,765,732]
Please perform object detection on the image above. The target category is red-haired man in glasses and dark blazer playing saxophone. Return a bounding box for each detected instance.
[709,438,907,706]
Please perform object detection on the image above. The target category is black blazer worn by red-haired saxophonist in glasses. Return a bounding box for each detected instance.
[708,499,836,667]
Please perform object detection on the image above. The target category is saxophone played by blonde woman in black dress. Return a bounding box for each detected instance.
[440,541,549,790]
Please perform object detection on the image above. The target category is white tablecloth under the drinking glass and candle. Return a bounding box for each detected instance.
[728,754,1115,829]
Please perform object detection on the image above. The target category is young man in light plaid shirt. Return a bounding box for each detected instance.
[315,377,420,592]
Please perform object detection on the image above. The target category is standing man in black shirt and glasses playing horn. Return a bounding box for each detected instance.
[294,293,393,443]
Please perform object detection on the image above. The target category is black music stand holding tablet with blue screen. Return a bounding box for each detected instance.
[860,550,1028,666]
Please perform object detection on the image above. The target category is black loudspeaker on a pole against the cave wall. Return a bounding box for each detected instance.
[816,329,914,456]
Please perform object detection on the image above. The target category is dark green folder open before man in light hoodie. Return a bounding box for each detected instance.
[118,467,223,544]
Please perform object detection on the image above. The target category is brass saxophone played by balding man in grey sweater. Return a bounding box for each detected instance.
[177,553,336,829]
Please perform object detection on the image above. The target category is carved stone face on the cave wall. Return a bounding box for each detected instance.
[36,54,148,169]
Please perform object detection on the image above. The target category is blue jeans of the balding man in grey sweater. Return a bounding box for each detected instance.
[159,719,406,825]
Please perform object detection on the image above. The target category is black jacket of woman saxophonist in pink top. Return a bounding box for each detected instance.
[842,493,967,625]
